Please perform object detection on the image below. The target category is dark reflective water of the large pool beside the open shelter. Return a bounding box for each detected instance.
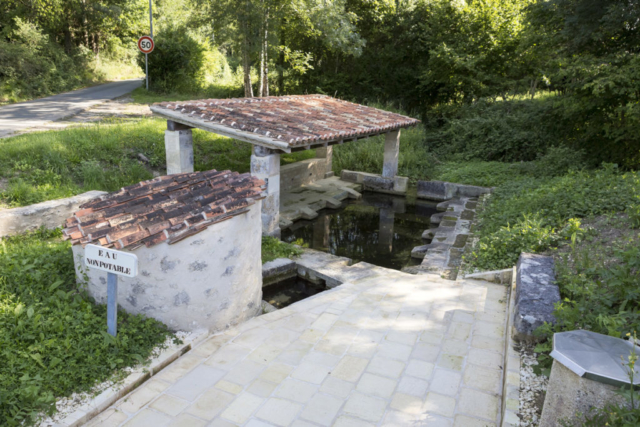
[282,193,437,269]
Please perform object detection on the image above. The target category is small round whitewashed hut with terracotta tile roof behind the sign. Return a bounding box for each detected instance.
[64,170,265,332]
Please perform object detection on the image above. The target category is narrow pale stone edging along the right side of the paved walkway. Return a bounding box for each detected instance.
[500,266,521,427]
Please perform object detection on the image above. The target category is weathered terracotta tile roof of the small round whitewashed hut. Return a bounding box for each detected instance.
[63,170,265,250]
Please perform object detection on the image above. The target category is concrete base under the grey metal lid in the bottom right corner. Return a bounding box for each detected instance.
[539,360,628,427]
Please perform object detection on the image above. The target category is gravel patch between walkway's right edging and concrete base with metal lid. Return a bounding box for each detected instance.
[518,345,549,427]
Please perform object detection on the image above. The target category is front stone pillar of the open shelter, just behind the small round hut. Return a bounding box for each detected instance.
[251,145,280,238]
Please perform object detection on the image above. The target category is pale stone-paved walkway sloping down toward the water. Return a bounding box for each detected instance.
[89,264,507,427]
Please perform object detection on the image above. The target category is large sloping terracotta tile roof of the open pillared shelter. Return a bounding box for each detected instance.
[151,95,420,147]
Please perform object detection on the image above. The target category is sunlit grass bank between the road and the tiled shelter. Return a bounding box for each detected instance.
[0,118,315,207]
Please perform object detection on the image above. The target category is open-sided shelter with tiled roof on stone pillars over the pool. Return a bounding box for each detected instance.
[151,95,419,236]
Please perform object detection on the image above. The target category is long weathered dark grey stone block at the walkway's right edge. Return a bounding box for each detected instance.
[512,252,560,341]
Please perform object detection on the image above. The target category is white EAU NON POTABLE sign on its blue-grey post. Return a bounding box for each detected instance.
[84,245,138,337]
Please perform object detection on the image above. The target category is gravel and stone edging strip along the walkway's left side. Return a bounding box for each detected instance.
[47,331,209,427]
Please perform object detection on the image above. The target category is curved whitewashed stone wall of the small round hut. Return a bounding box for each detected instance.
[73,201,262,332]
